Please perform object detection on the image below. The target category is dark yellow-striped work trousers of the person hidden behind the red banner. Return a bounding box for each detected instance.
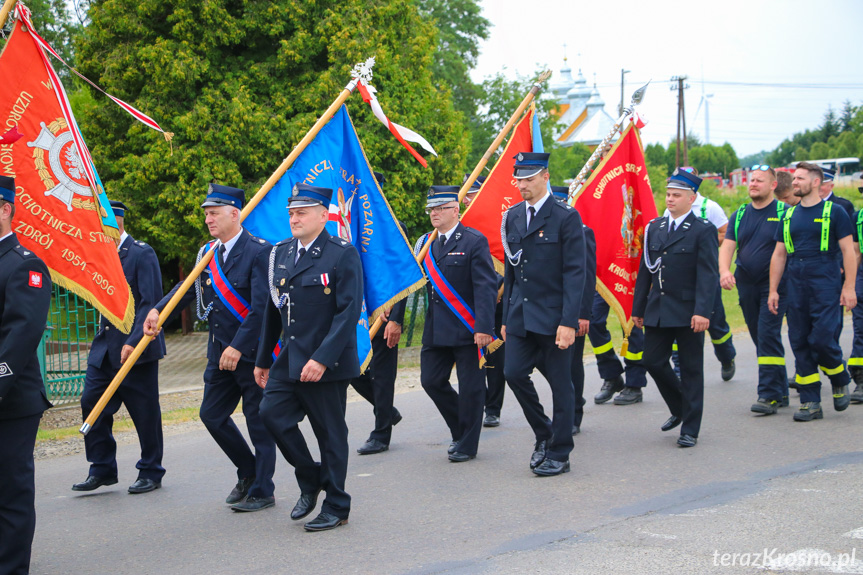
[587,292,647,387]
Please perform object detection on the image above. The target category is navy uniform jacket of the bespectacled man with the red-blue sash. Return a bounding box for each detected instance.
[423,223,497,347]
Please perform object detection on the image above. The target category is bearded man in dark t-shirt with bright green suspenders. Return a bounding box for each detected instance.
[768,162,857,421]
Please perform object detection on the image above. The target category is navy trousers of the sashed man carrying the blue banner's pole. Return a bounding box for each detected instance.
[200,358,276,497]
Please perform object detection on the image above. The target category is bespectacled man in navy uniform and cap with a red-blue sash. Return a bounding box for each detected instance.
[417,186,497,463]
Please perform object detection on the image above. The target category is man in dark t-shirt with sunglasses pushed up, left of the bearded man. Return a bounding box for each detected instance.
[719,165,788,415]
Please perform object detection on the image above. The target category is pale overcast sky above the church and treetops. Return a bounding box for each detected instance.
[472,0,863,157]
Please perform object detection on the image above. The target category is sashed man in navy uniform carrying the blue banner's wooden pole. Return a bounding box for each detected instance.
[144,184,276,512]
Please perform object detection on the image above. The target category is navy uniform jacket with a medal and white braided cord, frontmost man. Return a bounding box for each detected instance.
[255,230,363,381]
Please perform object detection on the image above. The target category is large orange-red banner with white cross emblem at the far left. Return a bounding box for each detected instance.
[0,20,135,333]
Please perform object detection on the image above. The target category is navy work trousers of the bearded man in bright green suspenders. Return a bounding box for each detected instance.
[785,254,850,403]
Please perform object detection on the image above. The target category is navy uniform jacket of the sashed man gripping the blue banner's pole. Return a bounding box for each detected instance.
[156,229,273,363]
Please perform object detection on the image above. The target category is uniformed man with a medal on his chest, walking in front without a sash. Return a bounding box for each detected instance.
[255,184,363,531]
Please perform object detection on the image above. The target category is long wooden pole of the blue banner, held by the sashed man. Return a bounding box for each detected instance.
[76,63,374,435]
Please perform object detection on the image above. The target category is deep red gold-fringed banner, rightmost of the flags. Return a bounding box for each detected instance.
[574,122,658,335]
